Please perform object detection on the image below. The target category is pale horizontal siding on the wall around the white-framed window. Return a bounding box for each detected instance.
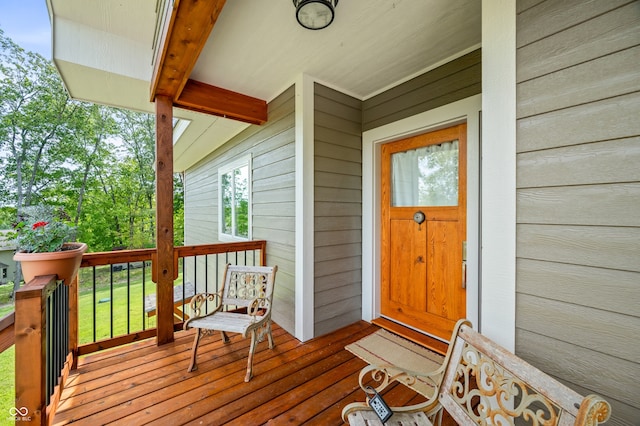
[185,87,295,333]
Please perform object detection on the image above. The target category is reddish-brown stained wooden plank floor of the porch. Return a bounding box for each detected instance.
[54,322,428,426]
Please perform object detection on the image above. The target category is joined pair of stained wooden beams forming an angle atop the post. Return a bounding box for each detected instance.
[151,0,267,124]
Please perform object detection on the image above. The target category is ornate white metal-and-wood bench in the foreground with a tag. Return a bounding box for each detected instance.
[342,320,611,426]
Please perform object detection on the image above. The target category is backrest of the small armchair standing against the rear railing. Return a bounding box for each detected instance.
[222,264,278,312]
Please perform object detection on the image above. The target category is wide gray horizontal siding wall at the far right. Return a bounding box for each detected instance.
[516,0,640,425]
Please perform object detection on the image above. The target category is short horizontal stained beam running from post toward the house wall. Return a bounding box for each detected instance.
[174,79,267,124]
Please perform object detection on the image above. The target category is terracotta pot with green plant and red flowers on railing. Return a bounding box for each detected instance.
[13,206,87,284]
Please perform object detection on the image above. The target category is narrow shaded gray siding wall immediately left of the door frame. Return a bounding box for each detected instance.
[314,84,362,336]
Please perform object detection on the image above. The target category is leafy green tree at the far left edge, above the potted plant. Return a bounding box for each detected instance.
[0,30,78,212]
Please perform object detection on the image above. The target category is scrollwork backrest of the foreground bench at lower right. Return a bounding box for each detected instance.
[439,322,610,425]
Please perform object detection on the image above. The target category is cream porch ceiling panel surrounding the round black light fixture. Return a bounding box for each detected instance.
[192,0,481,100]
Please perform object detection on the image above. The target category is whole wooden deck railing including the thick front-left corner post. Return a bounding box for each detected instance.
[11,241,266,424]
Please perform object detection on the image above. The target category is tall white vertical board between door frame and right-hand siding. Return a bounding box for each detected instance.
[474,0,516,352]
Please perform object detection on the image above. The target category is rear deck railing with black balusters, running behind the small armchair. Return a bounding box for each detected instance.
[77,241,266,355]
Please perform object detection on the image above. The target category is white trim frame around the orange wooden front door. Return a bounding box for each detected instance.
[362,95,482,340]
